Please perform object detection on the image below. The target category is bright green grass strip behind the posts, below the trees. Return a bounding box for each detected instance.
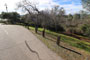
[30,27,90,52]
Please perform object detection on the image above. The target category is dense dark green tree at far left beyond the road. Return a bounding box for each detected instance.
[1,12,20,24]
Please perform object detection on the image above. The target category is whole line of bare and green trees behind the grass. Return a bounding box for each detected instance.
[0,0,90,37]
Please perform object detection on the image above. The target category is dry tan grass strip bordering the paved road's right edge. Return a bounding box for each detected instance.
[28,26,90,60]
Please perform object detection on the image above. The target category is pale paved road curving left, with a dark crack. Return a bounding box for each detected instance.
[0,24,63,60]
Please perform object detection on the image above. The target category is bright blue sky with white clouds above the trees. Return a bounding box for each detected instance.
[0,0,83,14]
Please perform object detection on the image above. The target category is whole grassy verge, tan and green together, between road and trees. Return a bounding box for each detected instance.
[30,27,90,60]
